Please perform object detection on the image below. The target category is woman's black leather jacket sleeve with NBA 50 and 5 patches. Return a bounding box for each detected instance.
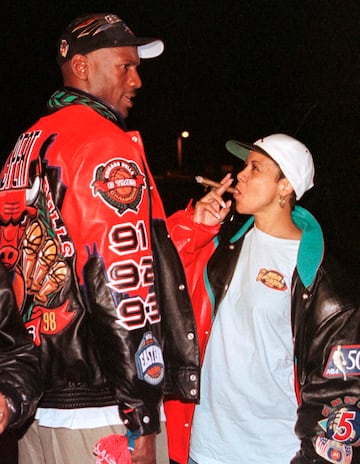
[292,259,360,464]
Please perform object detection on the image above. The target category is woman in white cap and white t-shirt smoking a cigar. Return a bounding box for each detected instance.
[165,134,360,464]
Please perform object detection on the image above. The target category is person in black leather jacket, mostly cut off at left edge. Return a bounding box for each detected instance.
[0,262,41,463]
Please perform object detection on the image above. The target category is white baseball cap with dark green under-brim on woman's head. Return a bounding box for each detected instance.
[225,134,315,200]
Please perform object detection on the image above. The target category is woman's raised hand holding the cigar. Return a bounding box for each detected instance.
[193,174,233,226]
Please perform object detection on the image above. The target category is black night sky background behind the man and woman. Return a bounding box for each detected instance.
[0,0,360,276]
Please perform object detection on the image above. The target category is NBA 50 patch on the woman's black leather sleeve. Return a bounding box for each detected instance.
[323,345,360,380]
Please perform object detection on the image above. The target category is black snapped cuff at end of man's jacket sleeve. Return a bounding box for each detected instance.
[119,404,160,436]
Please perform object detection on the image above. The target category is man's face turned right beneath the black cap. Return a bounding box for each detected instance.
[87,46,142,118]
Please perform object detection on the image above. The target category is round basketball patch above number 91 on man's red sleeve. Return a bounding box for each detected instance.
[91,158,145,216]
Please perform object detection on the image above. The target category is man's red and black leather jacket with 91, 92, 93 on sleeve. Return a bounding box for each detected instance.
[0,88,199,434]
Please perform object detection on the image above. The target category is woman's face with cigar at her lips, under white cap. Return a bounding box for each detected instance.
[234,151,283,215]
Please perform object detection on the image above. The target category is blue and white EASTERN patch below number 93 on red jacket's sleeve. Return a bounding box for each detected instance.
[135,332,165,385]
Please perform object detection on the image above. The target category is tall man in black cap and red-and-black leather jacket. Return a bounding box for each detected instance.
[0,14,198,464]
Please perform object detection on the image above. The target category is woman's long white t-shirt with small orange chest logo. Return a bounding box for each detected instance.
[190,228,299,464]
